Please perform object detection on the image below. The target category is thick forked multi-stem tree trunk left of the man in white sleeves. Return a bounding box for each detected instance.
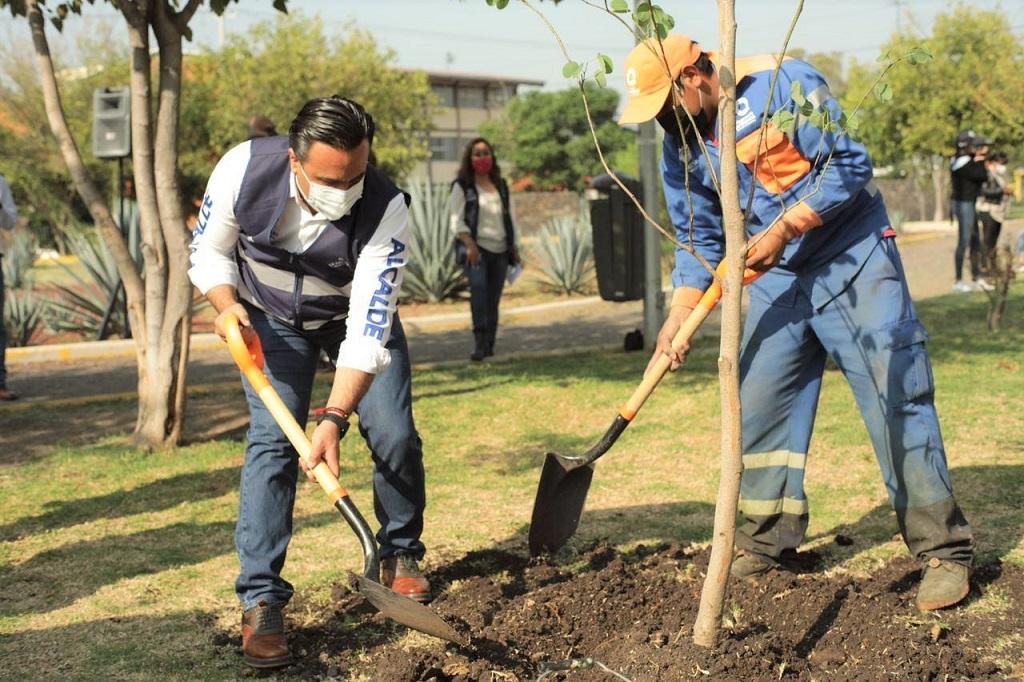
[27,0,194,449]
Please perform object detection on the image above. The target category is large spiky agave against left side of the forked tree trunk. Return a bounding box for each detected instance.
[46,224,125,336]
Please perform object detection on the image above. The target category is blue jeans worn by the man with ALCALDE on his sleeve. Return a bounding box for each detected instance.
[234,305,426,608]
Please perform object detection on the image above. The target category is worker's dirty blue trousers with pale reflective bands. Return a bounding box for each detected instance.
[736,239,974,563]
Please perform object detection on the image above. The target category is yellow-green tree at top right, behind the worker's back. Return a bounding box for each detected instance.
[844,6,1024,220]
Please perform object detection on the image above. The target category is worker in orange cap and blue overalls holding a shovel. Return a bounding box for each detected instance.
[620,35,974,610]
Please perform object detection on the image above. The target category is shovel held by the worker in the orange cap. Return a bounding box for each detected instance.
[529,262,761,556]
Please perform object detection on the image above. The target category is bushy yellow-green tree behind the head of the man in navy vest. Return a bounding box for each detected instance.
[180,14,433,186]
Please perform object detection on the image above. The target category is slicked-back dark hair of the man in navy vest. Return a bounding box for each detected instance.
[288,95,374,161]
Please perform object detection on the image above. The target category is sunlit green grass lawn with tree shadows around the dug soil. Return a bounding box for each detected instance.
[0,287,1024,680]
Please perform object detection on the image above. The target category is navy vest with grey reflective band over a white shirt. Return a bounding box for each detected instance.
[234,136,401,330]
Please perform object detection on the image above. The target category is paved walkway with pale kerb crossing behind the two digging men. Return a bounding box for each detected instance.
[0,228,983,413]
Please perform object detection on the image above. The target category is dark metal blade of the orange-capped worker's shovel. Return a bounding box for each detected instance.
[529,453,594,556]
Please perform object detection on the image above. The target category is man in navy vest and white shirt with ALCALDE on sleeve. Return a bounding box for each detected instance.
[188,95,430,668]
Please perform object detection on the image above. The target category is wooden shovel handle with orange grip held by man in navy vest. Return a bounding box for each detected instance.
[224,314,348,504]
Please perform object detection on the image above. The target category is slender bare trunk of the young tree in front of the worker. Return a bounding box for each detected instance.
[693,0,745,647]
